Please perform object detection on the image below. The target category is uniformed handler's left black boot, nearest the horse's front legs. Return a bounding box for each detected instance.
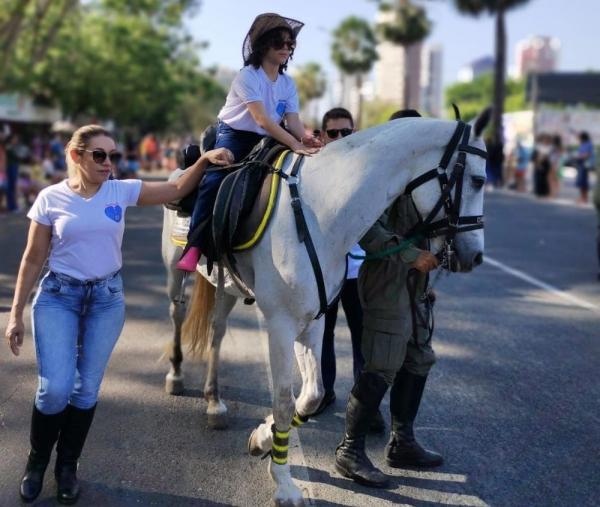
[335,371,388,488]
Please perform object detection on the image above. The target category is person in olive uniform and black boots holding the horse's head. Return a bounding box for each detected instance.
[335,110,443,487]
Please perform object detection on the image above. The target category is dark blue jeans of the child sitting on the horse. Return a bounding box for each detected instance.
[189,121,263,248]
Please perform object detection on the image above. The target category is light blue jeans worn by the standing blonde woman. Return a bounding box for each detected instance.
[32,272,125,414]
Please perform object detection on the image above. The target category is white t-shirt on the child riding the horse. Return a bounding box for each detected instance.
[219,65,299,135]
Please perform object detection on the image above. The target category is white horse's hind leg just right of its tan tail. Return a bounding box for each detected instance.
[204,294,237,430]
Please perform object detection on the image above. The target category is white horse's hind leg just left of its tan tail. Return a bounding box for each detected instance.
[165,270,187,395]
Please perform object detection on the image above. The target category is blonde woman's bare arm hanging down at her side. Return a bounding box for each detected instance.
[5,220,52,356]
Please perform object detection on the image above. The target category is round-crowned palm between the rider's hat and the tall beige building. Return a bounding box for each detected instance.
[331,16,377,126]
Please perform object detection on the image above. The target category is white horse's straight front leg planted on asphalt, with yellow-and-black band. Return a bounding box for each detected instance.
[248,319,304,507]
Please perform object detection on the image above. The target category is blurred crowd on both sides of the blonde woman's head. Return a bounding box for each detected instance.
[0,130,190,213]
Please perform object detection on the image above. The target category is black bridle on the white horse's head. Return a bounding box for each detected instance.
[404,120,487,267]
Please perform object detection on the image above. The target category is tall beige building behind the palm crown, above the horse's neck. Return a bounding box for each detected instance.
[375,11,422,109]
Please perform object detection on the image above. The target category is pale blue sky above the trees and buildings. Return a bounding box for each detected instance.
[187,0,600,85]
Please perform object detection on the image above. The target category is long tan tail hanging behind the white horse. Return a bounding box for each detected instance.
[181,273,216,358]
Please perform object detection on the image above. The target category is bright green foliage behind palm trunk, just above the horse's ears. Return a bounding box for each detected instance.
[445,72,527,128]
